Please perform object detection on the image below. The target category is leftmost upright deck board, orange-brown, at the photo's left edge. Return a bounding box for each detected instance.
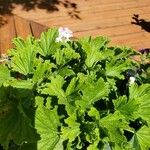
[0,16,16,54]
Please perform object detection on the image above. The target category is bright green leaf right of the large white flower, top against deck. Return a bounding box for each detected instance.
[80,37,108,68]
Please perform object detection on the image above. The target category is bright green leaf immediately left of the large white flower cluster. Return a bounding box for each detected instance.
[36,28,60,56]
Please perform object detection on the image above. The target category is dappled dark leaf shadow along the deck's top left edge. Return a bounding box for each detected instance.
[0,0,81,26]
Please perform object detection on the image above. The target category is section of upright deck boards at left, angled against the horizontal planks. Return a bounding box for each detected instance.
[0,15,48,54]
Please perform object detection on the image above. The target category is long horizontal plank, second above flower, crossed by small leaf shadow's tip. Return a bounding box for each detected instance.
[36,6,150,24]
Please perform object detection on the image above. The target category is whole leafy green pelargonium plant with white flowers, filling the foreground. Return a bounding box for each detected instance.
[0,29,150,150]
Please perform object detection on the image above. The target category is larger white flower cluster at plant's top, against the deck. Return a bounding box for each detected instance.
[56,27,73,42]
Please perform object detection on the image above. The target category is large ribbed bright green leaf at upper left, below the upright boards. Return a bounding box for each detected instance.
[10,37,35,75]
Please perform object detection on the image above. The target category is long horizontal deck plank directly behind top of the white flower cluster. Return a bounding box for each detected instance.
[44,12,150,32]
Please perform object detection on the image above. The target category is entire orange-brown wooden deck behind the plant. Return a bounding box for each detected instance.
[0,0,150,53]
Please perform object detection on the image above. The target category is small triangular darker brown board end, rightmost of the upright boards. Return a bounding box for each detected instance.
[30,21,48,38]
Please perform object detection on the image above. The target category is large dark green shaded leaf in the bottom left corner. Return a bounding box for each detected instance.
[0,102,39,150]
